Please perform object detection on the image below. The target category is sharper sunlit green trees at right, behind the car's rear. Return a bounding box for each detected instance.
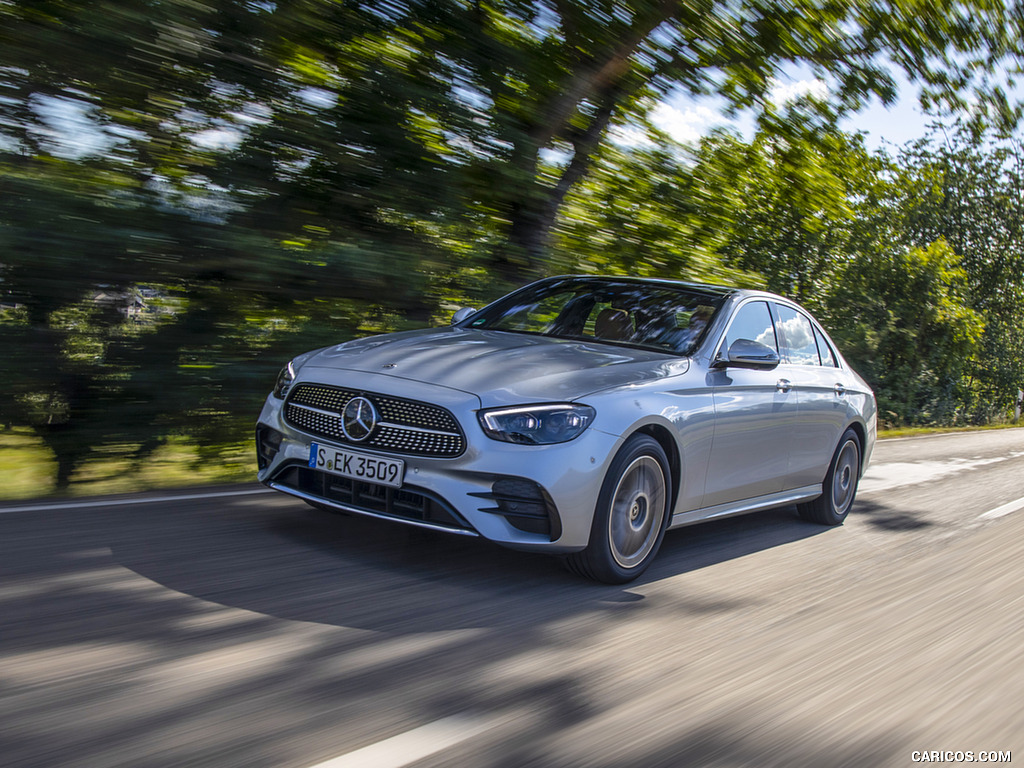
[697,126,1024,424]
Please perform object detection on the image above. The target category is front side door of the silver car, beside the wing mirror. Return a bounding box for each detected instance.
[702,299,798,508]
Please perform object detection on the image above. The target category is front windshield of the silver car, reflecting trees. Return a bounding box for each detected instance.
[466,278,725,355]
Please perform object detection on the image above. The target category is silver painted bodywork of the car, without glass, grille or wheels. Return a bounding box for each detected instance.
[258,280,876,553]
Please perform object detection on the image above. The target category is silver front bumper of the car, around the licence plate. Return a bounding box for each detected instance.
[257,374,621,553]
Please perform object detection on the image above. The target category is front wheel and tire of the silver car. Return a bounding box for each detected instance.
[564,434,672,584]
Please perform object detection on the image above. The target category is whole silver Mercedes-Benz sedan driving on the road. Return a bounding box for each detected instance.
[256,276,877,584]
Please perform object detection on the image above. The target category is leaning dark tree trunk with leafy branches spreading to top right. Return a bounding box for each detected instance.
[423,0,1020,281]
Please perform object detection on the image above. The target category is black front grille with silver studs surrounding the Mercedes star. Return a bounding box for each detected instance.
[285,384,466,459]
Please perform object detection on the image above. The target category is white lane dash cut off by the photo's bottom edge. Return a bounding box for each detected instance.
[312,715,489,768]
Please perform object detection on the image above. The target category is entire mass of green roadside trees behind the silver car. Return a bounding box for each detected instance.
[0,0,1024,488]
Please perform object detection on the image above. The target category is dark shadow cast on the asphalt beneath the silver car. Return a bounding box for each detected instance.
[90,502,827,634]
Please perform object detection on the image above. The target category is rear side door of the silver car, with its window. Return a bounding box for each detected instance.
[772,302,847,488]
